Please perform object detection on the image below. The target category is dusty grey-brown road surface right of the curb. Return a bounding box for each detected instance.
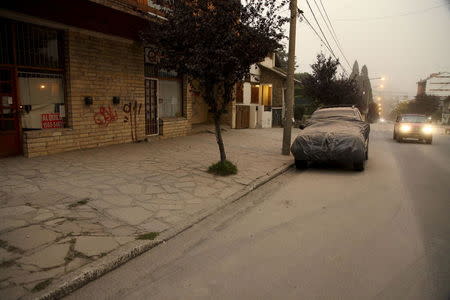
[68,125,450,299]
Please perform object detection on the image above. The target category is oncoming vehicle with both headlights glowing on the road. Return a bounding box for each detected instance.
[393,114,433,144]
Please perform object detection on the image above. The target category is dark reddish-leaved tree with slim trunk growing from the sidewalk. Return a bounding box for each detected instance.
[143,0,287,172]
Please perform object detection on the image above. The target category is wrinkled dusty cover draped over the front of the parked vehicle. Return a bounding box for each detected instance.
[291,116,370,161]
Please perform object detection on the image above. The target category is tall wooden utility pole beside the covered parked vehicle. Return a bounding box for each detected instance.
[281,0,297,155]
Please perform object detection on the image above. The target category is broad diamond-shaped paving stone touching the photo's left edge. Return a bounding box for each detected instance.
[0,225,58,250]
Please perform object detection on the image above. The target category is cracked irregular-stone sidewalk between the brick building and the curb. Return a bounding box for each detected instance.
[0,128,295,299]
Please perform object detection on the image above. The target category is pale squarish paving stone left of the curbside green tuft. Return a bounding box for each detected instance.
[75,236,119,256]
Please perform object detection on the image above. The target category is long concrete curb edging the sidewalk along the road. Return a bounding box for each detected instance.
[30,163,293,300]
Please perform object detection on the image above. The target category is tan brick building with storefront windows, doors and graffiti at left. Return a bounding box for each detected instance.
[0,0,192,157]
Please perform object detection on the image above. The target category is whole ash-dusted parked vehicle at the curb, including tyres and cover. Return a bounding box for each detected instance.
[291,106,370,171]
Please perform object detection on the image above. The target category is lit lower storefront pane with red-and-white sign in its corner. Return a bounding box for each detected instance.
[19,72,66,130]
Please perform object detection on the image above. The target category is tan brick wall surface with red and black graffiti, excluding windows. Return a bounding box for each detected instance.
[24,31,192,157]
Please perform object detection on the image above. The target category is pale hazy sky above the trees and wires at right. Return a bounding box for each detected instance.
[285,0,450,97]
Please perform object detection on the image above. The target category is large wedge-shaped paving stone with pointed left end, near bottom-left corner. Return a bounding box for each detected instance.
[18,244,70,268]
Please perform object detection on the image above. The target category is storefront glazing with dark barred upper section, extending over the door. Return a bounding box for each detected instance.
[0,18,67,130]
